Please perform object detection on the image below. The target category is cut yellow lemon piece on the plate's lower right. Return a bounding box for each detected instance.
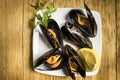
[78,48,100,72]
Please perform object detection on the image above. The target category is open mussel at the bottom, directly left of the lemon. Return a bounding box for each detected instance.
[65,45,86,80]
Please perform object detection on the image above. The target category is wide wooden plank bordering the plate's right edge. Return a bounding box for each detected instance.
[85,0,116,80]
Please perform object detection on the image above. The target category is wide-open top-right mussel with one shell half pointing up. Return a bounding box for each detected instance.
[68,3,97,37]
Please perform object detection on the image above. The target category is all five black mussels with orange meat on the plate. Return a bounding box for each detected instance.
[34,4,97,80]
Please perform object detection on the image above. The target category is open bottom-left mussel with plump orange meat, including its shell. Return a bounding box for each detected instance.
[34,48,67,70]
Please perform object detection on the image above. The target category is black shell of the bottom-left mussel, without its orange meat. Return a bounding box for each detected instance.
[34,48,67,70]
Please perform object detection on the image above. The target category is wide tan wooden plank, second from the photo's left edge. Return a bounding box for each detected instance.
[5,0,23,80]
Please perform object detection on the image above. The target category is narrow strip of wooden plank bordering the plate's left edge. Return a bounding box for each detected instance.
[23,0,35,80]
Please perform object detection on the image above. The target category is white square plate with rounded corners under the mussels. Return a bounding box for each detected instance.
[33,8,102,76]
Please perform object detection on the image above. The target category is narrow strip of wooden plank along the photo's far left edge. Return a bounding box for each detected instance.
[0,0,7,80]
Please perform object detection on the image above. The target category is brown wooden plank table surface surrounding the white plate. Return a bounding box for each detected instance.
[0,0,120,80]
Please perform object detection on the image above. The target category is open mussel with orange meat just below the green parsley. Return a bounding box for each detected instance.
[40,19,63,48]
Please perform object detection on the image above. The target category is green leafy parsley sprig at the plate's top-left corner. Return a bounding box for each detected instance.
[30,1,57,28]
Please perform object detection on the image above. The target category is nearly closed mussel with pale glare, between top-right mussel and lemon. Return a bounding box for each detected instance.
[61,22,92,48]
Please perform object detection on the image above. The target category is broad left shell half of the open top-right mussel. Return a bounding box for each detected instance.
[68,9,96,37]
